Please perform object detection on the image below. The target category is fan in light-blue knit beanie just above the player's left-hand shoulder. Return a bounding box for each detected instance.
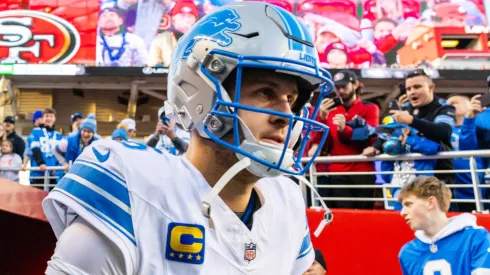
[53,114,98,171]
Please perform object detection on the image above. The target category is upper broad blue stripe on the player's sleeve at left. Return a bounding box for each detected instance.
[70,162,131,207]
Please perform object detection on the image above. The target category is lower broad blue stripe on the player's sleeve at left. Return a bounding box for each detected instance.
[57,177,134,238]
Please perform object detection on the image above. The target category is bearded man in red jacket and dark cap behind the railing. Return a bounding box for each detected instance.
[309,70,379,209]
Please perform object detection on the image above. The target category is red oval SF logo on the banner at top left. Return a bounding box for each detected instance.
[0,10,80,64]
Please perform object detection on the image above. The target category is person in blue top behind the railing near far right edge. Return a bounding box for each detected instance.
[447,95,486,212]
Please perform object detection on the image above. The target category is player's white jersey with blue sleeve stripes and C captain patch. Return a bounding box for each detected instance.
[43,140,314,275]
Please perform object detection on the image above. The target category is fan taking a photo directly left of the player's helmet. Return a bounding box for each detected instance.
[146,108,190,156]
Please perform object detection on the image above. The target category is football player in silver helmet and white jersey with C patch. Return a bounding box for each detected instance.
[43,2,333,274]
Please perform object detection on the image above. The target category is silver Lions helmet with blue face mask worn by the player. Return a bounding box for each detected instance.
[164,2,334,177]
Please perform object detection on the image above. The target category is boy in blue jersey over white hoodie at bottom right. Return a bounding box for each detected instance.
[398,176,490,275]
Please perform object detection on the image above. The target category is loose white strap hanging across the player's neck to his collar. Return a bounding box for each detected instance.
[201,158,251,219]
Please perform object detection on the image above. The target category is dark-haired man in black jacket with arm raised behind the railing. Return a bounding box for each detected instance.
[377,69,455,187]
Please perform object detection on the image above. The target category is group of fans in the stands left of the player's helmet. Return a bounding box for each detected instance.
[0,108,190,189]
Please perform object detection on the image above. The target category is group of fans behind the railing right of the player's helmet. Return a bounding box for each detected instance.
[308,69,490,212]
